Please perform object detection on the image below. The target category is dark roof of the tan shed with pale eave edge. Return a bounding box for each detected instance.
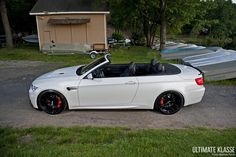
[30,0,109,15]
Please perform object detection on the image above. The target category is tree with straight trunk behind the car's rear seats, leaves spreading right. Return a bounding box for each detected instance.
[159,0,200,50]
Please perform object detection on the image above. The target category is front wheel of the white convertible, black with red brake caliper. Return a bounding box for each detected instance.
[37,91,68,115]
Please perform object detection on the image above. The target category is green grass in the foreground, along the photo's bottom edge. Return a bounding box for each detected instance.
[0,127,236,157]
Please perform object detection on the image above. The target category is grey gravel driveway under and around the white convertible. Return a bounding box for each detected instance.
[0,61,236,128]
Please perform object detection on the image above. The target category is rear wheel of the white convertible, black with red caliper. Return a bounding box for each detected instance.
[154,91,184,115]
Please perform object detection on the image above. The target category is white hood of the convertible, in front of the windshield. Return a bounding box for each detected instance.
[37,65,82,80]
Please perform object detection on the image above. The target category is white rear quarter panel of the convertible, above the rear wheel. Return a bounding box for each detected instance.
[132,75,185,109]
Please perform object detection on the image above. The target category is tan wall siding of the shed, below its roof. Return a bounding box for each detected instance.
[36,14,107,48]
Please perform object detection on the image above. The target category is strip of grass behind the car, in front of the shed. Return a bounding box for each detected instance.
[0,46,164,66]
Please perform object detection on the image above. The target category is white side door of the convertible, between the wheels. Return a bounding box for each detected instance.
[78,77,138,108]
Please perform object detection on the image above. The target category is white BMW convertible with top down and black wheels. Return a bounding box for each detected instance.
[29,55,205,114]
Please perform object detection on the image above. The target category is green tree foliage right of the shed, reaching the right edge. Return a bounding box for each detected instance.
[109,0,236,47]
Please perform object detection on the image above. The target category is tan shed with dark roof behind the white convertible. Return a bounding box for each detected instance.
[30,0,109,53]
